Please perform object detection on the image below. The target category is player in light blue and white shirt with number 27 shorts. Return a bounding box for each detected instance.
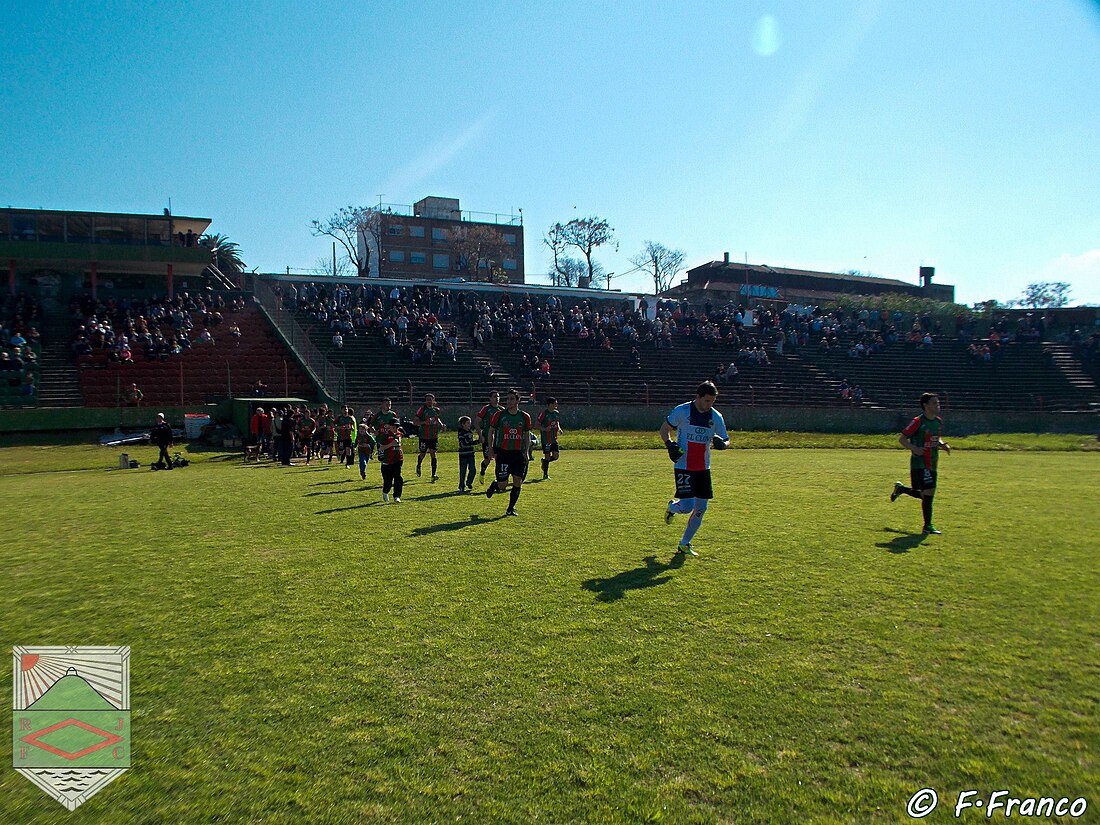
[661,381,729,556]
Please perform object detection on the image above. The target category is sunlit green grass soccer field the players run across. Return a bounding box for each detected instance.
[0,442,1100,823]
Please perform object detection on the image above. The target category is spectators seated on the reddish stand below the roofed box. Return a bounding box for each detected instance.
[69,293,245,366]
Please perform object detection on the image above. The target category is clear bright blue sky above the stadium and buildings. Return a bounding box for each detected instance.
[0,0,1100,304]
